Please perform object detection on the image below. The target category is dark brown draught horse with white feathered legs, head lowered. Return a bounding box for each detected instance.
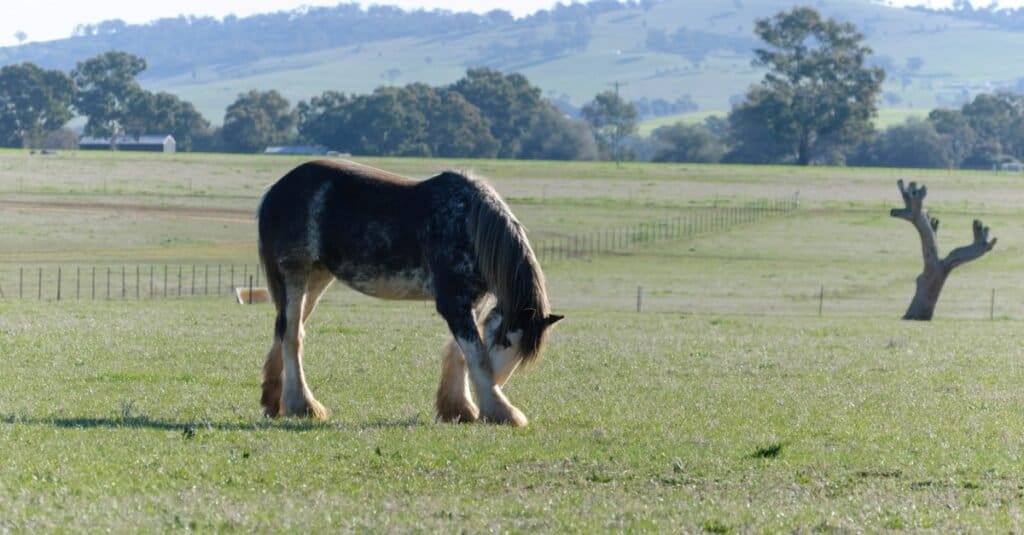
[257,157,561,426]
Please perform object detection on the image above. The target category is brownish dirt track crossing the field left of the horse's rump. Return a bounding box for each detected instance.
[0,200,256,223]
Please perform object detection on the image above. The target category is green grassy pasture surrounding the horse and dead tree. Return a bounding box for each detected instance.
[0,153,1024,533]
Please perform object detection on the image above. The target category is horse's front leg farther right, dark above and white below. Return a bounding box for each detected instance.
[438,303,529,427]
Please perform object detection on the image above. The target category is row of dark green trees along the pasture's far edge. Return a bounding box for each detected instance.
[6,7,1024,168]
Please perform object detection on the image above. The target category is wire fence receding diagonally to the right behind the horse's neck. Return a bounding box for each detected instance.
[534,195,800,262]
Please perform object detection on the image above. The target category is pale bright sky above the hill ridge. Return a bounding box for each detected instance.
[0,0,1024,46]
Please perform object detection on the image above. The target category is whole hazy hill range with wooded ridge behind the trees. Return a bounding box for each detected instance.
[0,0,1024,123]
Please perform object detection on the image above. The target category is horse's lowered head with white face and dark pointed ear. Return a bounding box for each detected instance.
[482,306,564,386]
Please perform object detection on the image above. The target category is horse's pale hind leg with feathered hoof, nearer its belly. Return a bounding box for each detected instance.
[280,268,328,420]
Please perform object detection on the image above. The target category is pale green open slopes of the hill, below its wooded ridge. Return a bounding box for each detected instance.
[147,0,1024,119]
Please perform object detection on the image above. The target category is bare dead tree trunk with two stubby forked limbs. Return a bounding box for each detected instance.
[889,180,995,321]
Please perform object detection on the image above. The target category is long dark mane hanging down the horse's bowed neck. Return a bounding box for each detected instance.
[468,180,550,362]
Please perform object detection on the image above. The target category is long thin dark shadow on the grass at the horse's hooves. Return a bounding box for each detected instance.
[0,414,430,435]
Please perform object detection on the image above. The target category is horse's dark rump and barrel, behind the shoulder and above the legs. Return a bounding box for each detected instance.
[258,157,444,298]
